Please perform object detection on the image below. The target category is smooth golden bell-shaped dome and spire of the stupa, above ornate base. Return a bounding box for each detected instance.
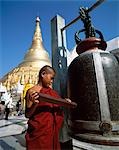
[19,17,51,68]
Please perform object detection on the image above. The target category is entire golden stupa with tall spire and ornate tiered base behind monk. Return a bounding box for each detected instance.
[0,17,51,91]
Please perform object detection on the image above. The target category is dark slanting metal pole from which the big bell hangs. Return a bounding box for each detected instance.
[61,0,105,32]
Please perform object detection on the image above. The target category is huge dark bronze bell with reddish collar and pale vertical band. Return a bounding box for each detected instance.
[68,6,119,145]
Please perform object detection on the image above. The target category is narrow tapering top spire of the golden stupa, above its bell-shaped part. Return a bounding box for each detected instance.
[31,17,44,50]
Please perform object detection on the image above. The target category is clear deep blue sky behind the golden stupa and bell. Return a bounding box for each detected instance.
[0,0,119,78]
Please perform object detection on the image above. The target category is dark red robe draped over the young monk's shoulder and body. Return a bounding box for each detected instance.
[25,88,63,150]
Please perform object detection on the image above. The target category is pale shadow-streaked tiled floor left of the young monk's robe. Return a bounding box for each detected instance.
[0,116,27,150]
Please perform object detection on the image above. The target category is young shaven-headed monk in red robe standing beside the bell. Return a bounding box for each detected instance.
[25,65,67,150]
